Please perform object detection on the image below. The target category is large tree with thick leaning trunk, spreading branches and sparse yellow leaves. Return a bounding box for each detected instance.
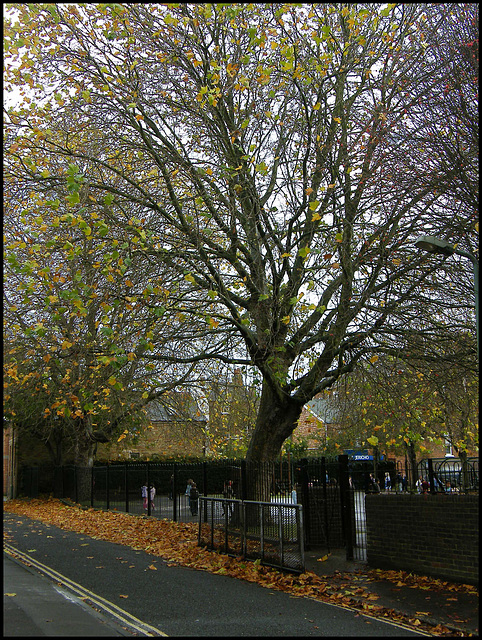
[6,3,474,460]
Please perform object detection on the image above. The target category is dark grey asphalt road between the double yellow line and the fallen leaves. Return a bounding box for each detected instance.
[4,513,424,637]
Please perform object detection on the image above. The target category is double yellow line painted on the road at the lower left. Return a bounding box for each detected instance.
[4,543,167,637]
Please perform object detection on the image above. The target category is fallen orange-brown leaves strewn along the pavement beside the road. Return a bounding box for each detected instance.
[4,498,477,637]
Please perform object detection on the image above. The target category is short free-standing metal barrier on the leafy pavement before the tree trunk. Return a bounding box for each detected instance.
[198,497,305,573]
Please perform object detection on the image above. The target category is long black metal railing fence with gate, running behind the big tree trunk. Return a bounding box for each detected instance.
[18,455,479,561]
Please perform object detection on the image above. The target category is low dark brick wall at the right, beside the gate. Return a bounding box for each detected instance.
[365,494,479,584]
